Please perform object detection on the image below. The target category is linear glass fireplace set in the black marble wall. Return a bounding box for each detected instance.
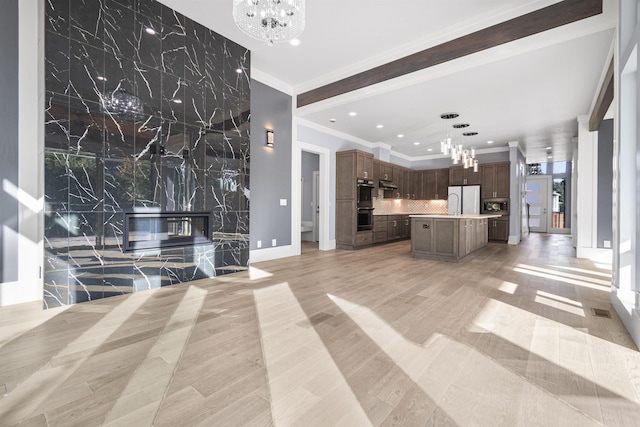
[123,212,212,252]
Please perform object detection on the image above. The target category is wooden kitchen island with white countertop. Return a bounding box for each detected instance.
[410,214,501,261]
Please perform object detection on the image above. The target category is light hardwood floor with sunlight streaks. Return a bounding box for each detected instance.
[0,235,640,426]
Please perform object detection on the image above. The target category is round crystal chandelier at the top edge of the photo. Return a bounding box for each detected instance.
[233,0,304,46]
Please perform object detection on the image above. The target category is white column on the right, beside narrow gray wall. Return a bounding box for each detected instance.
[576,116,600,258]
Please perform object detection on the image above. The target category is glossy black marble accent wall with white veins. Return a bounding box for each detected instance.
[44,0,250,307]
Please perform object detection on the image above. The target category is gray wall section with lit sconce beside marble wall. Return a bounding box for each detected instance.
[249,80,292,249]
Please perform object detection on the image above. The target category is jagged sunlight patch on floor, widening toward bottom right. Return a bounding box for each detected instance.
[329,295,600,426]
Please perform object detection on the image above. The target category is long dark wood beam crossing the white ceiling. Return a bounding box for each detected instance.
[297,0,602,108]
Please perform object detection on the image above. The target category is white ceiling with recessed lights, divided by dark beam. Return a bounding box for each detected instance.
[161,0,617,163]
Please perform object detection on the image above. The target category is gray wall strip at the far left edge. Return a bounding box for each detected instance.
[0,0,19,288]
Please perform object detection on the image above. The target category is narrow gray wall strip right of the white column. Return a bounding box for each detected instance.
[598,119,613,248]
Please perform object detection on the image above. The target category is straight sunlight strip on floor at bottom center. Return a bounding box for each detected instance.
[254,283,371,426]
